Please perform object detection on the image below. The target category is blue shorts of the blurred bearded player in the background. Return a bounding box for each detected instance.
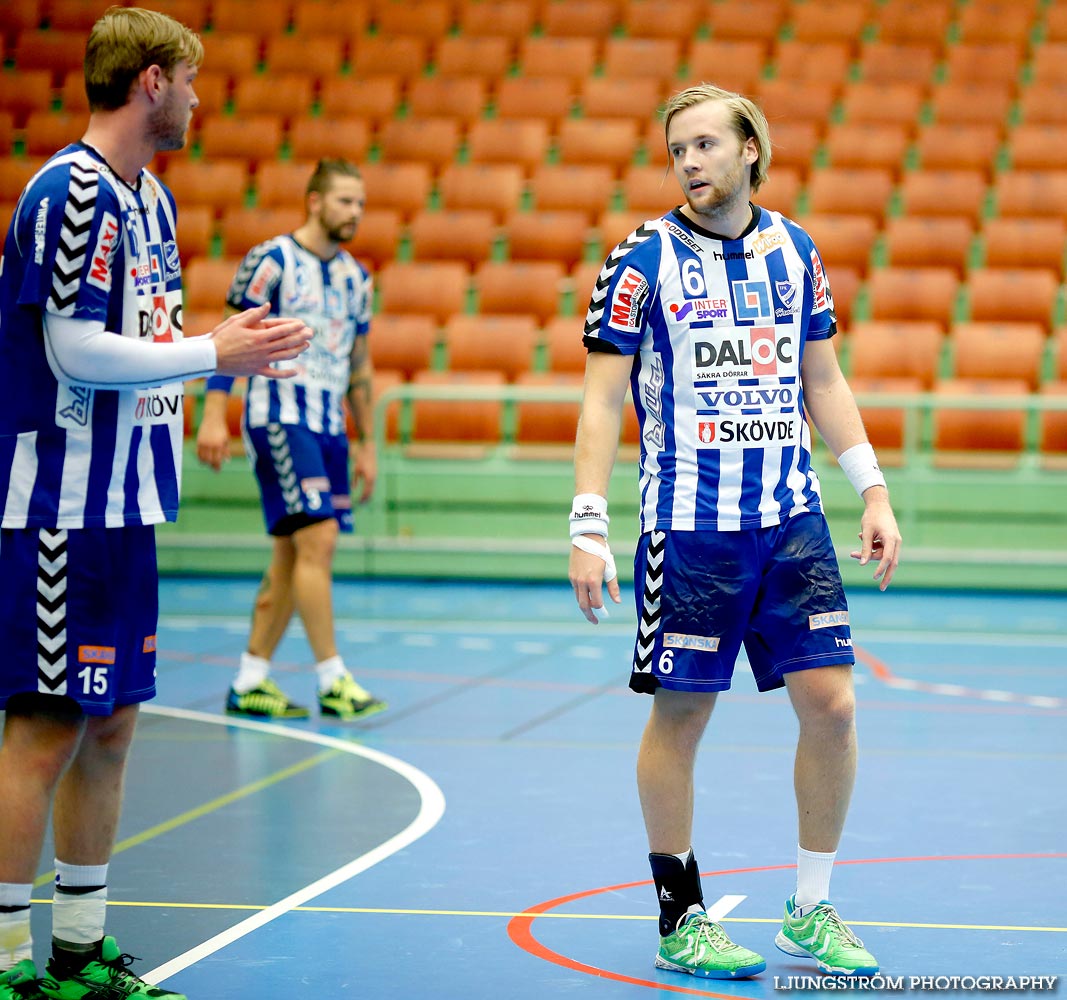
[244,424,352,536]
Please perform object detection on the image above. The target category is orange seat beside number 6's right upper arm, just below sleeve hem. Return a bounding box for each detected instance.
[848,320,944,390]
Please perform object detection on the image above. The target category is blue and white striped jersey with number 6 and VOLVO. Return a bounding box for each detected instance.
[585,208,837,533]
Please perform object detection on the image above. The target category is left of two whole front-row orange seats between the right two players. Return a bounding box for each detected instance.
[412,371,505,444]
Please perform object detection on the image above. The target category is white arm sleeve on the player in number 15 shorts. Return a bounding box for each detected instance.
[45,313,218,390]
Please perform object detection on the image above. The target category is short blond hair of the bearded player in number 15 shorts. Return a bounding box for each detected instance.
[85,6,204,111]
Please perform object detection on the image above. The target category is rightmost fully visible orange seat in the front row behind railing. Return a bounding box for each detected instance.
[934,379,1026,464]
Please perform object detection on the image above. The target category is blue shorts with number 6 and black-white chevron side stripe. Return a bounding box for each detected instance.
[630,513,856,694]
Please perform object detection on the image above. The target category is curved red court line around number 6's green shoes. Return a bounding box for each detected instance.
[508,853,1067,1000]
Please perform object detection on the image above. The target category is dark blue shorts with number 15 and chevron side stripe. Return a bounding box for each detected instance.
[0,525,159,715]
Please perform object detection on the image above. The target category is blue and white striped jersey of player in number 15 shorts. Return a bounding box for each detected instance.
[0,144,184,528]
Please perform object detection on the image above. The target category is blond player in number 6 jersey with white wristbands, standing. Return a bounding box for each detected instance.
[570,84,902,979]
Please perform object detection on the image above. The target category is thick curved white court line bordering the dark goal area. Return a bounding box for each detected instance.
[141,705,445,983]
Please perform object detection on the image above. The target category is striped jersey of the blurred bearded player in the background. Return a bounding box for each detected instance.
[207,236,372,435]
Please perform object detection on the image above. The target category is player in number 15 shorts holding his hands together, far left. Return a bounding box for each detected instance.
[0,7,310,1000]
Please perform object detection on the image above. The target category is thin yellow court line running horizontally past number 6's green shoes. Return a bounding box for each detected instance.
[25,900,1067,934]
